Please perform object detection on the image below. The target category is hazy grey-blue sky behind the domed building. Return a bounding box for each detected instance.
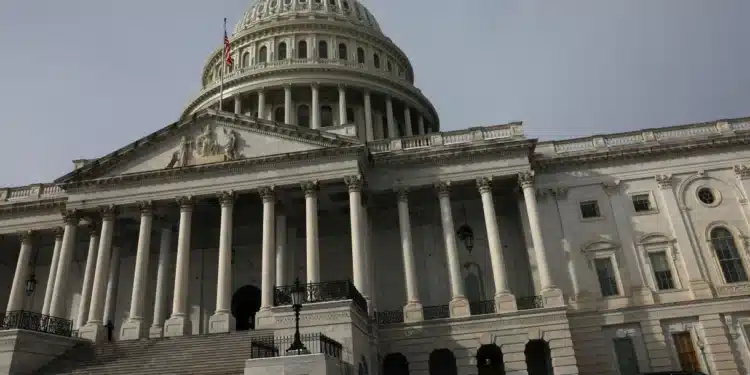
[0,0,750,187]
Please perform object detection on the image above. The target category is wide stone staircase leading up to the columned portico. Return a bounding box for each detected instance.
[34,331,273,375]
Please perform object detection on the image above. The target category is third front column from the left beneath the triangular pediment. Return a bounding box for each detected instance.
[120,203,153,340]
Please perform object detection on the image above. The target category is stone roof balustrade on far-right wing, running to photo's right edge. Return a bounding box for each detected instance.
[536,119,750,156]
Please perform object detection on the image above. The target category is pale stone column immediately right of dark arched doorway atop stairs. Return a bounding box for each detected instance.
[255,187,276,328]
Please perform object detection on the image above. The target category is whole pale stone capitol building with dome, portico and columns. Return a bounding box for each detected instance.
[0,0,750,375]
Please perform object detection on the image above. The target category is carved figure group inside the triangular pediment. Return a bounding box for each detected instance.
[166,125,241,168]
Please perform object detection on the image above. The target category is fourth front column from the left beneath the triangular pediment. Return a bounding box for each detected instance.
[164,197,193,337]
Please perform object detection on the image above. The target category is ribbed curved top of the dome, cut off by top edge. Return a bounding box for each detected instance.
[234,0,380,34]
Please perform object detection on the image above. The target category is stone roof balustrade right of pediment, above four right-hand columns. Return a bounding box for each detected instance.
[367,123,524,153]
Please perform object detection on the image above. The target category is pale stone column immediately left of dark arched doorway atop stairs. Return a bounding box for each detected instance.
[208,191,235,333]
